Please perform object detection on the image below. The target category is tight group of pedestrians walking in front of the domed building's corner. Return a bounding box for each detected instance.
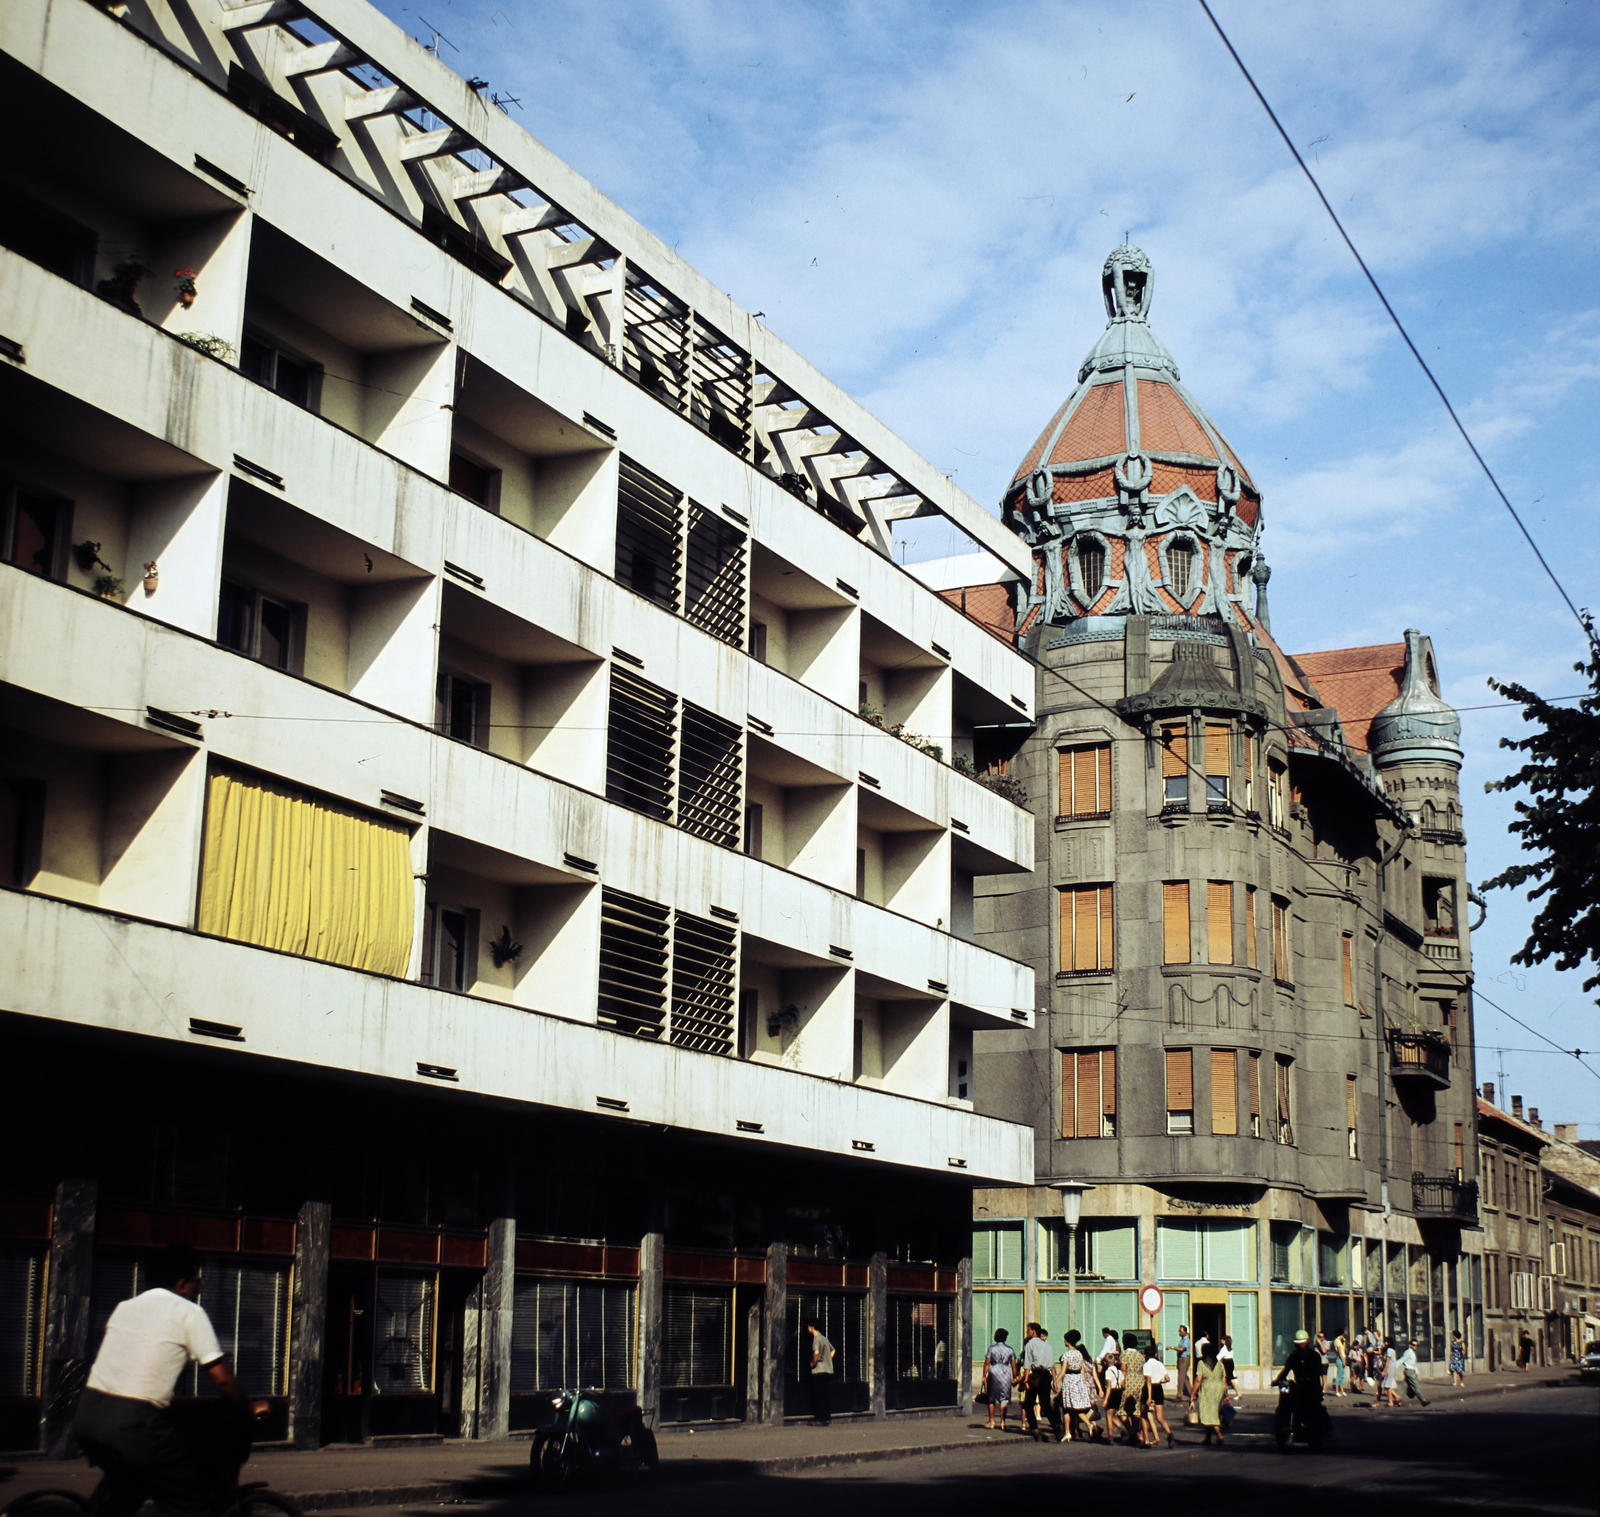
[984,1322,1234,1448]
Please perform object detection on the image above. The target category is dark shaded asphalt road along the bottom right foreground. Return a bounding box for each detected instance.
[318,1387,1600,1517]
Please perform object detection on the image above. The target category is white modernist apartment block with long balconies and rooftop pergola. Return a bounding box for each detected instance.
[0,0,1034,1448]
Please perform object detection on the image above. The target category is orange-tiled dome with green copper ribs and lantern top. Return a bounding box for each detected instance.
[1002,243,1264,627]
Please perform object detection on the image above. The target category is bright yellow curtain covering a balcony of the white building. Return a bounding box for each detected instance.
[200,773,413,975]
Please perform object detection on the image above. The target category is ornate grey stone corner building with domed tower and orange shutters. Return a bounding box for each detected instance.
[944,246,1483,1384]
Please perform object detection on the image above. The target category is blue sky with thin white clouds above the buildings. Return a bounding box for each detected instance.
[379,0,1600,1138]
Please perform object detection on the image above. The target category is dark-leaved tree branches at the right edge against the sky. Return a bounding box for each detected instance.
[1482,614,1600,1000]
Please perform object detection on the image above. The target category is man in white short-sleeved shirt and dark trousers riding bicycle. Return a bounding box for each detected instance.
[72,1243,269,1517]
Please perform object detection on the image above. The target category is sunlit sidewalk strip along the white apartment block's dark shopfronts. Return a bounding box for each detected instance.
[0,1408,1026,1512]
